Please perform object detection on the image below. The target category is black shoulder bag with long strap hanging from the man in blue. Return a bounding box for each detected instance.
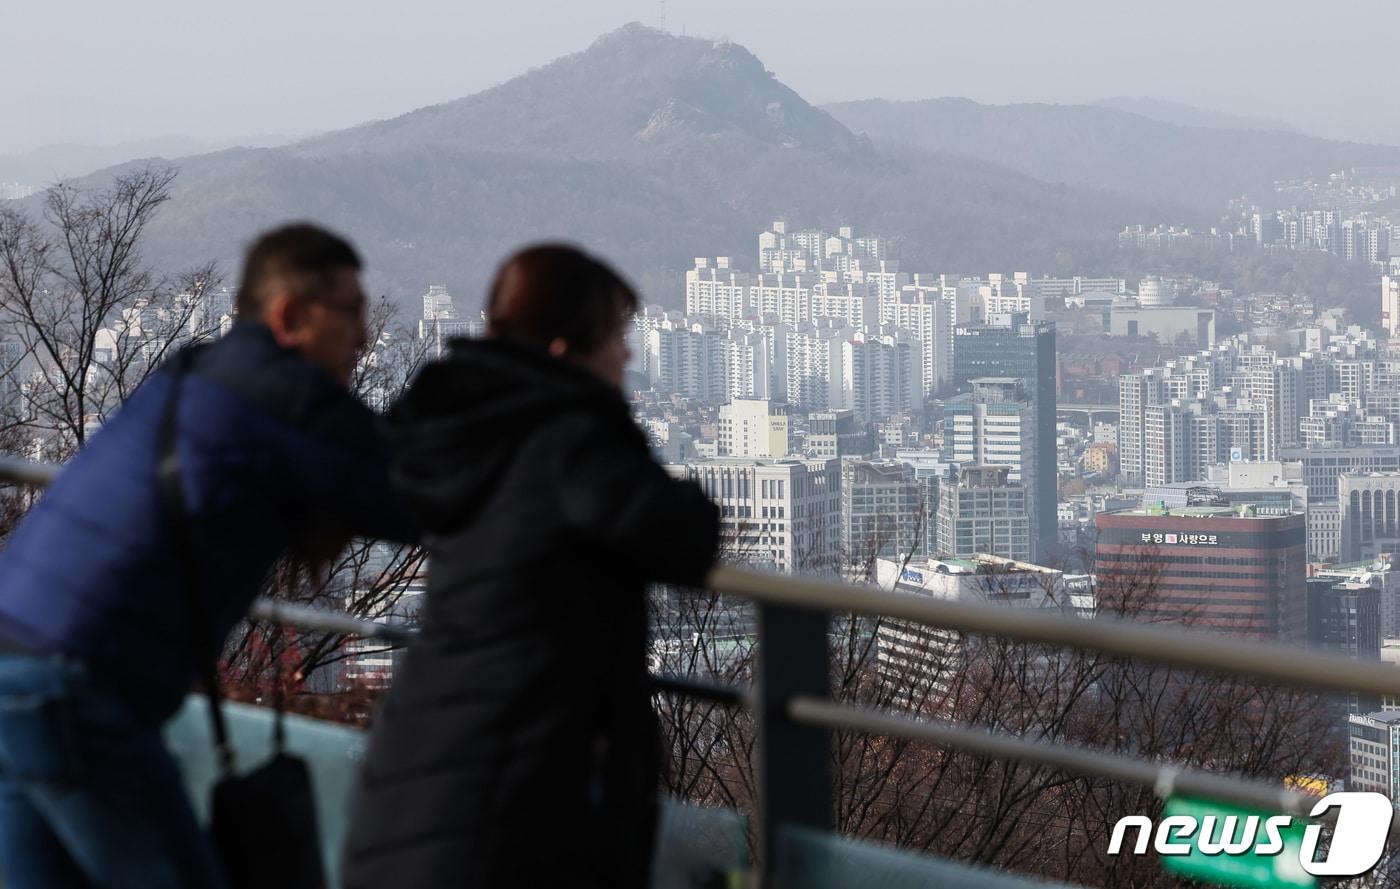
[155,349,326,889]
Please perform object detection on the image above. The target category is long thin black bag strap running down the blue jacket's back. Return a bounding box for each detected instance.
[155,346,234,777]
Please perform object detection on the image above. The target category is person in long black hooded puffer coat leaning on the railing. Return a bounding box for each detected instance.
[344,246,720,889]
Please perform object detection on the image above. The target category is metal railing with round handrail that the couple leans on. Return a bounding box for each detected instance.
[0,458,1400,886]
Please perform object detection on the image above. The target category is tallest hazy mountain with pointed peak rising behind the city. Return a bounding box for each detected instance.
[43,25,1176,311]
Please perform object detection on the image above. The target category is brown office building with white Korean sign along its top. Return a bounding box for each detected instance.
[1095,507,1308,644]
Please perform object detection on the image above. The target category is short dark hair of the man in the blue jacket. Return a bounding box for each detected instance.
[234,223,363,318]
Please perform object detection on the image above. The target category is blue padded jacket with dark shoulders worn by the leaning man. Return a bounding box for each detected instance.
[0,321,413,722]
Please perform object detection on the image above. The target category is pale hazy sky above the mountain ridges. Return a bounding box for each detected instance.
[0,0,1400,153]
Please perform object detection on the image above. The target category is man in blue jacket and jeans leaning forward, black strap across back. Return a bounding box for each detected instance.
[0,225,412,889]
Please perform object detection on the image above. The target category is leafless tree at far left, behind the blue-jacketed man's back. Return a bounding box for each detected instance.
[0,165,218,459]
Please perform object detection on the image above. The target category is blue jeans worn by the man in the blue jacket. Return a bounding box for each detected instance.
[0,654,223,889]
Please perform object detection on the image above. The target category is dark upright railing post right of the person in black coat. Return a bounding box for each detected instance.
[755,603,833,889]
